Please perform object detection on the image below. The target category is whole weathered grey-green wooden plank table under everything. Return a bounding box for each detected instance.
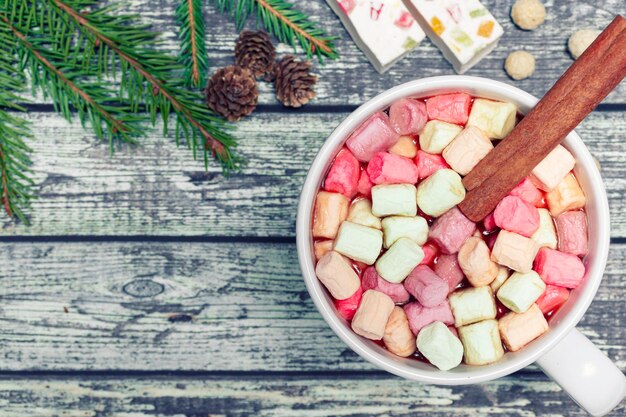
[0,0,626,417]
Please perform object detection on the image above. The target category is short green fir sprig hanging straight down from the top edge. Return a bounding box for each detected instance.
[176,0,209,87]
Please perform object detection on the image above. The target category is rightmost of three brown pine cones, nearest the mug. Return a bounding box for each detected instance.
[274,55,317,107]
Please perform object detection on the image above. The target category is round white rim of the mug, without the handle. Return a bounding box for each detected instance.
[296,75,610,385]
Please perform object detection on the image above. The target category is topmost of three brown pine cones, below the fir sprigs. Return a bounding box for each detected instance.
[235,30,276,81]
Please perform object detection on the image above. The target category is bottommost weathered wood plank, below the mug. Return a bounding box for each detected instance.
[0,374,625,417]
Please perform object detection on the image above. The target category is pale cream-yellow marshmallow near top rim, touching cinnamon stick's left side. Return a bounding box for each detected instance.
[467,98,517,139]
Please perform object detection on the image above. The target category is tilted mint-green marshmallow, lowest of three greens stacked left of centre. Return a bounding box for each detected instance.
[376,237,424,282]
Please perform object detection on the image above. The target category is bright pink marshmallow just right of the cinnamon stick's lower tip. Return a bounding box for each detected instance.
[493,195,539,237]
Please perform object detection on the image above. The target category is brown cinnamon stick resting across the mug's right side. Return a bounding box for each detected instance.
[459,16,626,221]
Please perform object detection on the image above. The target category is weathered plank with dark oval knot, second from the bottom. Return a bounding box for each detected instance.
[0,242,626,372]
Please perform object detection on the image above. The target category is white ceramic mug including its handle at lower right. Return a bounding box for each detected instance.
[296,76,626,416]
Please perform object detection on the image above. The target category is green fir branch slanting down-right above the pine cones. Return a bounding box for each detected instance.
[213,0,339,62]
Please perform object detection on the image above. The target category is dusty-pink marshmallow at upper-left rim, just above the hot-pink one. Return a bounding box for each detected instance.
[346,112,400,162]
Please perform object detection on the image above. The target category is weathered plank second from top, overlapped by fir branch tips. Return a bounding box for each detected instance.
[2,112,626,237]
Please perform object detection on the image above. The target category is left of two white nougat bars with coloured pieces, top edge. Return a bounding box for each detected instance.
[326,0,425,73]
